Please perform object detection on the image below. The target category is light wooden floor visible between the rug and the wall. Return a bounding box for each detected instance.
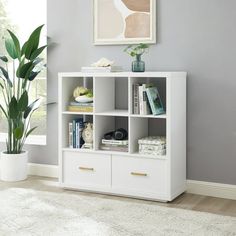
[0,176,236,217]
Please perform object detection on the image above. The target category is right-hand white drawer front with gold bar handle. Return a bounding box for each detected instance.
[112,155,167,195]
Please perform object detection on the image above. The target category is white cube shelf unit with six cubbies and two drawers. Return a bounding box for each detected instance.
[58,72,187,202]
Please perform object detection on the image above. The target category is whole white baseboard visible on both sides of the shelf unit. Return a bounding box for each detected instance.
[19,163,236,200]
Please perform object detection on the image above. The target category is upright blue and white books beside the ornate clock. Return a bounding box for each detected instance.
[69,118,84,148]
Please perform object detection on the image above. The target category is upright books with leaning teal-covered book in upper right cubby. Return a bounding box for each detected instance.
[133,84,165,115]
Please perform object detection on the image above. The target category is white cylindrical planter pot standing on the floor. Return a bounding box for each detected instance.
[0,151,28,182]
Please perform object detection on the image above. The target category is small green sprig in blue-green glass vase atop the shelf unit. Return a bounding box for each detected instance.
[124,43,149,72]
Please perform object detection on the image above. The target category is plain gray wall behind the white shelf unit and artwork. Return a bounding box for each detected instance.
[8,0,236,184]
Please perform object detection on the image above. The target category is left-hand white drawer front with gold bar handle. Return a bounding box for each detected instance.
[63,152,111,187]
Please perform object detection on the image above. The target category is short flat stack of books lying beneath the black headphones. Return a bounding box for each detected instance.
[100,139,129,152]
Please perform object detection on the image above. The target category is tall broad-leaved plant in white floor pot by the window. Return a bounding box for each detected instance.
[0,25,46,181]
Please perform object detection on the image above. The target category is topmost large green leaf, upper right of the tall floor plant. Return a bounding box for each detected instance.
[25,25,44,60]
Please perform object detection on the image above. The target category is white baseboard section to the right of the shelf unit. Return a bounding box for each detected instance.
[187,180,236,200]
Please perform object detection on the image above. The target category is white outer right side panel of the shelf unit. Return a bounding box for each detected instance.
[168,76,186,198]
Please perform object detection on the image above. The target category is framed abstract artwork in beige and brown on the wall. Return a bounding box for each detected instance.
[94,0,156,45]
